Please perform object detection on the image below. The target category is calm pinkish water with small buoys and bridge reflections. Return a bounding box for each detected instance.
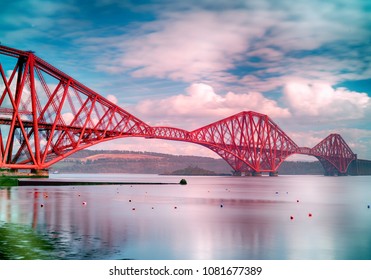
[0,174,371,260]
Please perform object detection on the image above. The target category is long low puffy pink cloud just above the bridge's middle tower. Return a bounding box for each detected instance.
[133,83,290,129]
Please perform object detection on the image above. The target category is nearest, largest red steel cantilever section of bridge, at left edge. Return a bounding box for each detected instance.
[0,46,150,169]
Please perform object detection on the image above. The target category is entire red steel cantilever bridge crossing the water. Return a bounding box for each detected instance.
[0,46,356,175]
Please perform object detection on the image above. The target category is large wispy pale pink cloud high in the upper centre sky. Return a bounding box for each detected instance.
[121,11,263,82]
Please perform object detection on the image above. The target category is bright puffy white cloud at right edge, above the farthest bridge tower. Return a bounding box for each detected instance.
[284,82,371,121]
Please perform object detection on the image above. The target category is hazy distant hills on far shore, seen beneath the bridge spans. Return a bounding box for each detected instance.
[51,150,323,175]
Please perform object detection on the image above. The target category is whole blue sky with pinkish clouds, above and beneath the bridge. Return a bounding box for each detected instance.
[0,0,371,160]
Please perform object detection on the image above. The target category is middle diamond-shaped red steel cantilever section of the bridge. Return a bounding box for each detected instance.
[191,111,298,172]
